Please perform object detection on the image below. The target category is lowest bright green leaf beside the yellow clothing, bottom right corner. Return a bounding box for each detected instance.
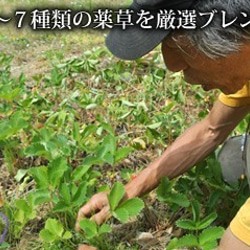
[199,227,225,246]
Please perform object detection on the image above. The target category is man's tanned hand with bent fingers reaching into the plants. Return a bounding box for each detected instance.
[76,192,111,231]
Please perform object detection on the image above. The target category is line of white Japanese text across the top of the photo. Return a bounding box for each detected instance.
[0,9,250,30]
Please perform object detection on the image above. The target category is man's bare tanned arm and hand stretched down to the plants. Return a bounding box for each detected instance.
[76,101,250,229]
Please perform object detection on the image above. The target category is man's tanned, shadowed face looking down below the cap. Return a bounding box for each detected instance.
[162,34,250,94]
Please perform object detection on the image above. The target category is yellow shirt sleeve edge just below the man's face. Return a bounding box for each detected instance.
[219,82,250,107]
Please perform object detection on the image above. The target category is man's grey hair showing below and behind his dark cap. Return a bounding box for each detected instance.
[185,0,250,59]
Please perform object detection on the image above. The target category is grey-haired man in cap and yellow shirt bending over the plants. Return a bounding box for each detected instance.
[77,0,250,250]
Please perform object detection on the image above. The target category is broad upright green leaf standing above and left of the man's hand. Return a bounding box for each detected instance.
[48,158,68,188]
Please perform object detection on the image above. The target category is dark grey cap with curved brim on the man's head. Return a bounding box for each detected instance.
[106,0,198,60]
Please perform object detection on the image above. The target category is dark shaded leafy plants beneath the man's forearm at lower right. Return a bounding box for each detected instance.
[157,155,249,250]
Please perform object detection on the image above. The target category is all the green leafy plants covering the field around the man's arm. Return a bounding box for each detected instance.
[0,41,247,250]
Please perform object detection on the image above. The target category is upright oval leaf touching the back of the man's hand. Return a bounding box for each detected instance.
[108,182,125,211]
